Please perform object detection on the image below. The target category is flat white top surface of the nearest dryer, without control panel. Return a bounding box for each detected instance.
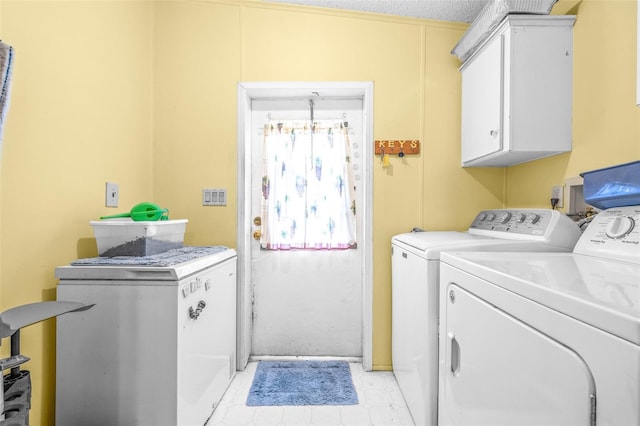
[441,252,640,345]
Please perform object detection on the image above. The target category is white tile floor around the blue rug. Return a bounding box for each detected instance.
[207,362,413,426]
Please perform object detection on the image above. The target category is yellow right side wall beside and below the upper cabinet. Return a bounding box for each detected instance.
[505,0,640,208]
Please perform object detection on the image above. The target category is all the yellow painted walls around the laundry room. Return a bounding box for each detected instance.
[0,0,640,425]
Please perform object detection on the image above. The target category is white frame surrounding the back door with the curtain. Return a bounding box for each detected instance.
[236,82,373,371]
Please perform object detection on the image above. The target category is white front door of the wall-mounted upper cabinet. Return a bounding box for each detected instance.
[462,36,504,165]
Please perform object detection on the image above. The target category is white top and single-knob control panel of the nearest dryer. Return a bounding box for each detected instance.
[442,206,640,345]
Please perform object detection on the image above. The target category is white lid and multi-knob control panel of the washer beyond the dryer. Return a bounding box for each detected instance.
[392,209,581,260]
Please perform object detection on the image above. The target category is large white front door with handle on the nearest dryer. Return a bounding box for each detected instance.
[439,284,595,426]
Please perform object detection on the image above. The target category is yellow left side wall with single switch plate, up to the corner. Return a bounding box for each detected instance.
[0,0,153,425]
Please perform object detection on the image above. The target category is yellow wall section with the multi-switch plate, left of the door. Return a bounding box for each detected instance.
[154,1,242,247]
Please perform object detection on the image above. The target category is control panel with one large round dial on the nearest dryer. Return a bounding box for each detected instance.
[574,206,640,264]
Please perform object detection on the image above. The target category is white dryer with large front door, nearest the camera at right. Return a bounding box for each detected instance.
[439,206,640,426]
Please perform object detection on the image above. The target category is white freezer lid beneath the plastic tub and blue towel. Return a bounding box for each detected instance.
[55,247,237,282]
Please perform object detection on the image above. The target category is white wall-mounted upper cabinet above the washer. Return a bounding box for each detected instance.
[460,15,575,167]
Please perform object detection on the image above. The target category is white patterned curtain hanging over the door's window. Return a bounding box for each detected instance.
[261,120,356,250]
